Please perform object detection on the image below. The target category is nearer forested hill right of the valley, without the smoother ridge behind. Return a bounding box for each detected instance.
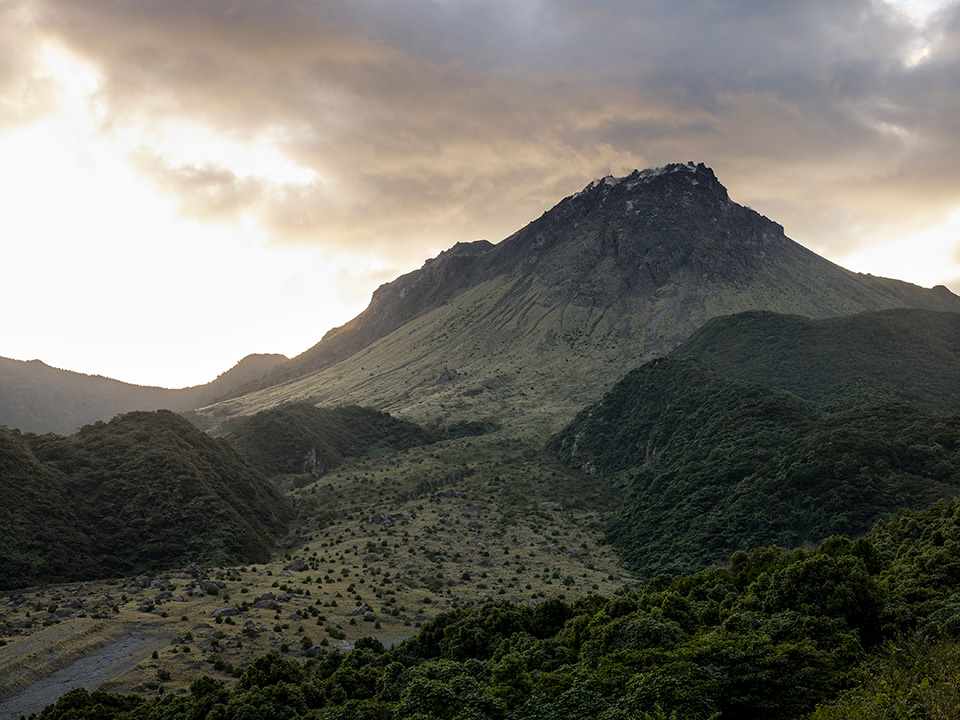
[554,358,960,575]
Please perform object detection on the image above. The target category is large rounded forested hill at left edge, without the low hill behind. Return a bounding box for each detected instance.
[0,410,292,590]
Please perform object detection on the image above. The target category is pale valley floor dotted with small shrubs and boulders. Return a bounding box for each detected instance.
[0,433,634,714]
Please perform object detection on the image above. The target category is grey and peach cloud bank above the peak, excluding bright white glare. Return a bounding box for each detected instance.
[22,0,960,261]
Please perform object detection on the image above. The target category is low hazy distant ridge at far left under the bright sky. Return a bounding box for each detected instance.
[0,355,287,434]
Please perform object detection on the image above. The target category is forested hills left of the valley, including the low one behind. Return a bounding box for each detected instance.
[0,404,490,590]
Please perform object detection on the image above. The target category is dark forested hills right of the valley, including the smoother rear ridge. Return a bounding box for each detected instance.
[553,310,960,574]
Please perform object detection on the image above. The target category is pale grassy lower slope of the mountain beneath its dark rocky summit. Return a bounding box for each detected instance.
[190,261,960,436]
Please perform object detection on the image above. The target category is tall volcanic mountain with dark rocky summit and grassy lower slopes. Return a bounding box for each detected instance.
[191,163,960,433]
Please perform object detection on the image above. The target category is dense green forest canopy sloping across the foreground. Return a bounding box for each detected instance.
[31,500,960,720]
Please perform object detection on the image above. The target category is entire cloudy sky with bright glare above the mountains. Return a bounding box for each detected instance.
[0,0,960,387]
